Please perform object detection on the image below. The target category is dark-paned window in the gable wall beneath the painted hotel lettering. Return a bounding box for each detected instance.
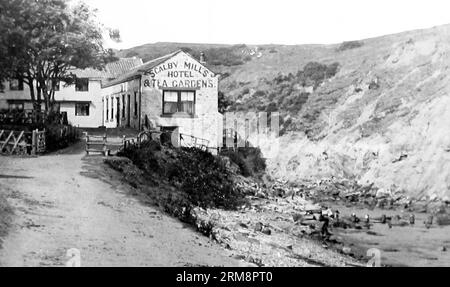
[163,91,195,115]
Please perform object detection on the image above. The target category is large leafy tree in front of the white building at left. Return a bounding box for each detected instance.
[0,0,119,113]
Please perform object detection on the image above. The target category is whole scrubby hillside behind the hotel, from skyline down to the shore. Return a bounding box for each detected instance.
[117,25,450,199]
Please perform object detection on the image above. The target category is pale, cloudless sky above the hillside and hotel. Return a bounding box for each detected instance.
[84,0,450,49]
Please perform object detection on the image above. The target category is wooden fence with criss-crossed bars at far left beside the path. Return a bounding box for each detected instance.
[0,129,45,155]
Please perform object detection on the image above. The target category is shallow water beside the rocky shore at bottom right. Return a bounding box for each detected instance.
[326,202,450,266]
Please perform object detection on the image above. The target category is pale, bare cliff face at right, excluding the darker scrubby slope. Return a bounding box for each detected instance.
[269,26,450,200]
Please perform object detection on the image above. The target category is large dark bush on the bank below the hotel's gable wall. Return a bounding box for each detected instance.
[121,141,244,212]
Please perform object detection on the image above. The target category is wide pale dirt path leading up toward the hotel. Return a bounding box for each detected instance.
[0,145,245,266]
